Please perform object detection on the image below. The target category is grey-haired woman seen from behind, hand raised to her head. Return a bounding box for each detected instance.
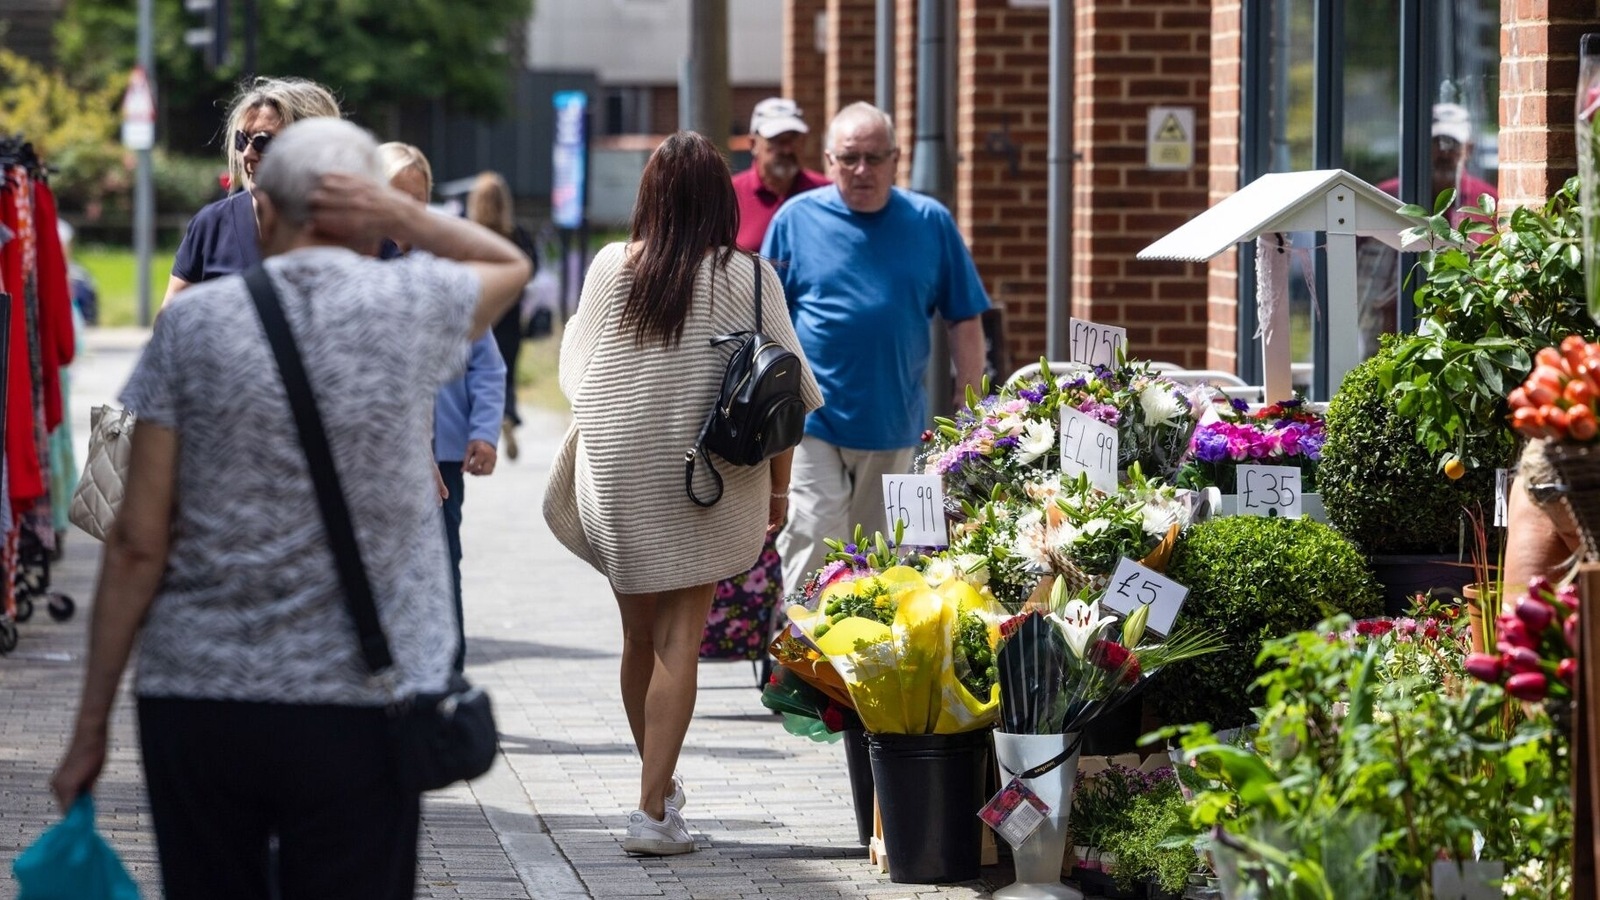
[51,119,528,900]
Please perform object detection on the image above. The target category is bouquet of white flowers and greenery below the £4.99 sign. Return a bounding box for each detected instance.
[946,464,1190,612]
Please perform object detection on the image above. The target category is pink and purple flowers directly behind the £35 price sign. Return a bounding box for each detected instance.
[1178,399,1326,493]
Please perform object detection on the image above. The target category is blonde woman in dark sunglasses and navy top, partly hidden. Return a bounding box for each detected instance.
[166,75,339,299]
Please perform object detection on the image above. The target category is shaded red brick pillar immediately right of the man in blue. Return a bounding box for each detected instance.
[952,0,1050,365]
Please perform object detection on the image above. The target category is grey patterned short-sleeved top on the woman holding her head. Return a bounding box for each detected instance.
[122,247,480,706]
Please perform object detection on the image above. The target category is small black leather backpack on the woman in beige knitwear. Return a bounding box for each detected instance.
[683,258,805,506]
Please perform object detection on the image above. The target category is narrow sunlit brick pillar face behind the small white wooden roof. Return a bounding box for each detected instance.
[1205,0,1243,372]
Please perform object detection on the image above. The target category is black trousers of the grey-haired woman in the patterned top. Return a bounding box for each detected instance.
[139,698,421,900]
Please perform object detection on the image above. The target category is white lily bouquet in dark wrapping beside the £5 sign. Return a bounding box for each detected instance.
[997,580,1222,735]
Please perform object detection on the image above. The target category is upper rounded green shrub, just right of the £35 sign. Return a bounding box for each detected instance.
[1317,338,1494,554]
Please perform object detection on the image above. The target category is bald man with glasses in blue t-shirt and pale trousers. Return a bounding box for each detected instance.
[762,102,989,589]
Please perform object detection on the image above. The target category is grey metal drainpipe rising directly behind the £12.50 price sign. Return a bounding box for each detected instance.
[1045,0,1077,360]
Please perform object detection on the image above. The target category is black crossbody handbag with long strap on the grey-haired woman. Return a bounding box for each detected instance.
[245,264,499,793]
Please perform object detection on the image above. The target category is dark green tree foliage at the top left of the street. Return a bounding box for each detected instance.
[56,0,531,131]
